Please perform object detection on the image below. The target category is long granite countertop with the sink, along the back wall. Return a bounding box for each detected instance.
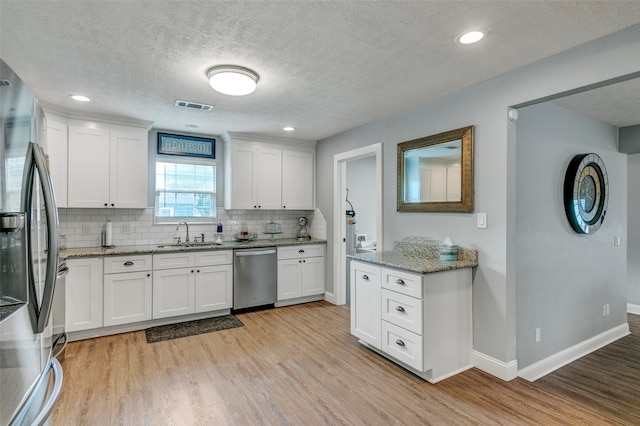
[60,238,327,259]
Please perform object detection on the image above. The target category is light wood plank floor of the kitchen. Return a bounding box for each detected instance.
[53,302,640,425]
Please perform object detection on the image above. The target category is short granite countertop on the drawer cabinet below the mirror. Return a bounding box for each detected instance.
[347,248,478,274]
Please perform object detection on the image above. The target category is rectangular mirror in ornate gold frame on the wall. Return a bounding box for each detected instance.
[397,126,473,213]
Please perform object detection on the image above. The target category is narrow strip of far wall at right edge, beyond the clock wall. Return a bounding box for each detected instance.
[627,154,640,313]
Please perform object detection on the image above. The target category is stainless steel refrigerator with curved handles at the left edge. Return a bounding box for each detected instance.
[0,59,64,426]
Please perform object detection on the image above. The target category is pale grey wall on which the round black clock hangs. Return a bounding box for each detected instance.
[515,103,627,369]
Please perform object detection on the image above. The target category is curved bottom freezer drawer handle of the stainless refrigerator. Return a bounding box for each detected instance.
[9,358,64,426]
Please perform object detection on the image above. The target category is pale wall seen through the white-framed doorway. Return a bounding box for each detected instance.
[347,156,378,241]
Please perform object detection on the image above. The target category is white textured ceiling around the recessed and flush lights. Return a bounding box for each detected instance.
[0,0,640,140]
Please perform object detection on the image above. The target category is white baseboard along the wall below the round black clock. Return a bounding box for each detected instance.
[518,323,630,382]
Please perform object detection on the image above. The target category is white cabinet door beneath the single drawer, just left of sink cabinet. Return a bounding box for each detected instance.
[104,271,152,327]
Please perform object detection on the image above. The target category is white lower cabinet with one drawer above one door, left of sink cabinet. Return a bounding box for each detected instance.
[104,255,152,327]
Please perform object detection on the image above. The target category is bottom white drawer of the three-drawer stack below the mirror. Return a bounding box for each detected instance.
[382,321,427,371]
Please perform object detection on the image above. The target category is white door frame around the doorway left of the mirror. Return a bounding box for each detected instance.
[332,143,384,305]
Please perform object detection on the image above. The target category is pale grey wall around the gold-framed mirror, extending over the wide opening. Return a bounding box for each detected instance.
[316,25,640,363]
